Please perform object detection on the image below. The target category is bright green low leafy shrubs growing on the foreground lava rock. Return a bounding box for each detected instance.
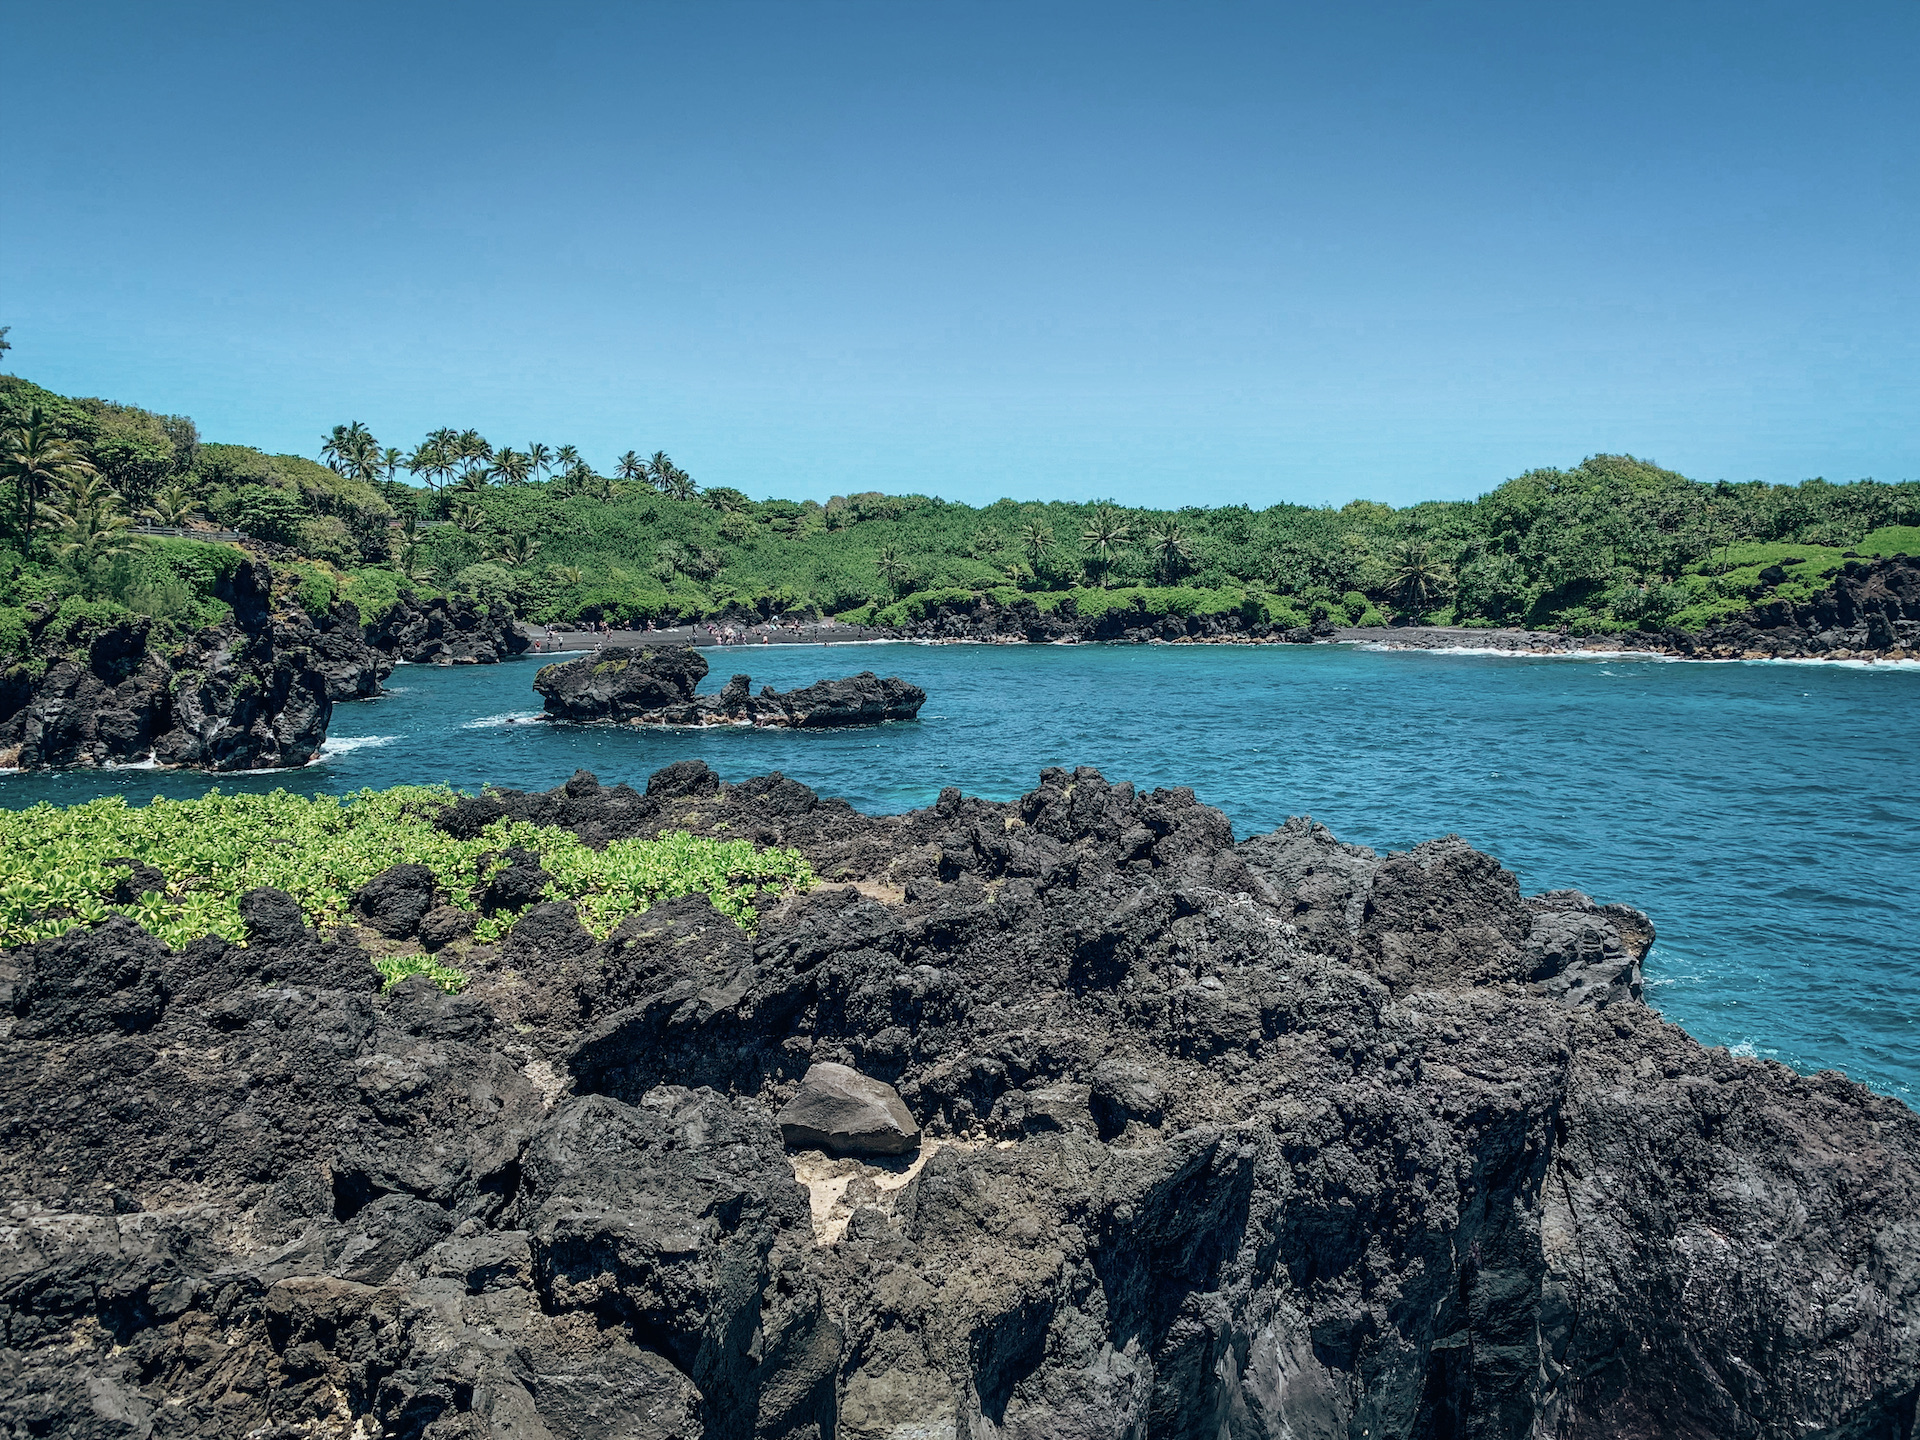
[0,785,814,948]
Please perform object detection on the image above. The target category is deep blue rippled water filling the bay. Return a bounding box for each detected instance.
[0,645,1920,1104]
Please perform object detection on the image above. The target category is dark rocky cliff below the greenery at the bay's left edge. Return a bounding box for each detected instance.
[0,559,337,770]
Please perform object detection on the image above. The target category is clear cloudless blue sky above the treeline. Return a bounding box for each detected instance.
[0,0,1920,505]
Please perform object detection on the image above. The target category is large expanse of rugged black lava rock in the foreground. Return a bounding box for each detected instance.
[0,762,1920,1440]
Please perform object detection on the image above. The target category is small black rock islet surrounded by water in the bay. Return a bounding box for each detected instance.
[534,645,927,730]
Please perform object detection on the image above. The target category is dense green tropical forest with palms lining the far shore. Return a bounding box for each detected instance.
[0,353,1920,653]
